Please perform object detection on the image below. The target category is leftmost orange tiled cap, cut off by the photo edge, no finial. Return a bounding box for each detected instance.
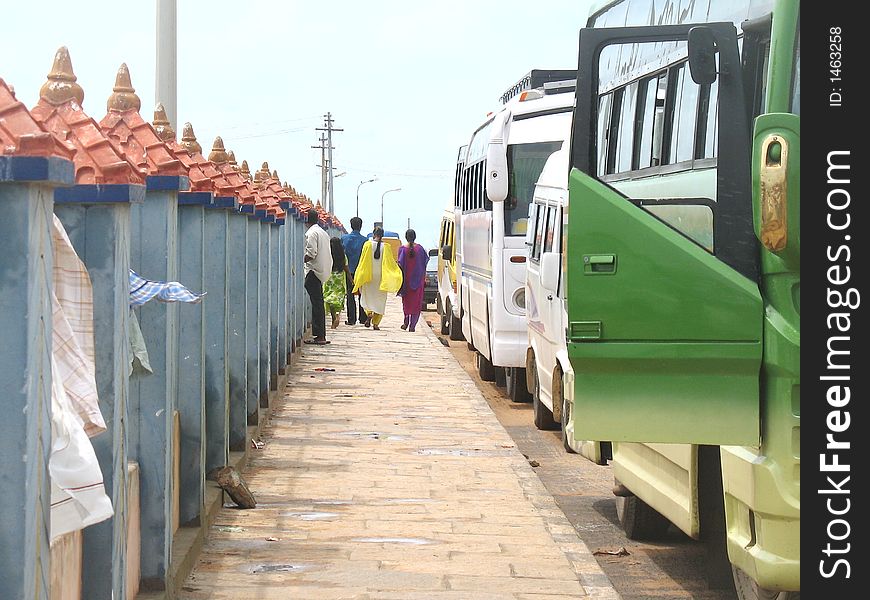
[0,77,75,160]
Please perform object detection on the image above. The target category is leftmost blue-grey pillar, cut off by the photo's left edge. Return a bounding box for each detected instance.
[0,156,73,600]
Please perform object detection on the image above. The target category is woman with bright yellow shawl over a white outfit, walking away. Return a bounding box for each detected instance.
[353,227,402,329]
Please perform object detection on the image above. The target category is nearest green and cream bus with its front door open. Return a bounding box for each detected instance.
[562,0,800,600]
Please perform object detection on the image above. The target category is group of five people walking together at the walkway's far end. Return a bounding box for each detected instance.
[304,209,429,345]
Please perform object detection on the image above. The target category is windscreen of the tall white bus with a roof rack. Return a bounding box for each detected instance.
[504,142,562,235]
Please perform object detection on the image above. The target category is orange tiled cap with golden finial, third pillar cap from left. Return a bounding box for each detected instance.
[100,64,187,176]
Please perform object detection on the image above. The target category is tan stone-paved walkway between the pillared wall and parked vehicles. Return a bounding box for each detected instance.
[180,299,618,600]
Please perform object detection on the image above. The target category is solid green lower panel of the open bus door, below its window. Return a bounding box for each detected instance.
[568,169,763,445]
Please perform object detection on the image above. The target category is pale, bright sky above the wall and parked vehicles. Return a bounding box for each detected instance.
[0,0,590,248]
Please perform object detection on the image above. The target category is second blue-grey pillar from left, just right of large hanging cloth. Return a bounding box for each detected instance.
[54,179,145,598]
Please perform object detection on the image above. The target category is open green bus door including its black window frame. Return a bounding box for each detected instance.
[567,23,763,445]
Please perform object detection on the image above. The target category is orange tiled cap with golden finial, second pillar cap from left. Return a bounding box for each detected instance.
[31,47,145,184]
